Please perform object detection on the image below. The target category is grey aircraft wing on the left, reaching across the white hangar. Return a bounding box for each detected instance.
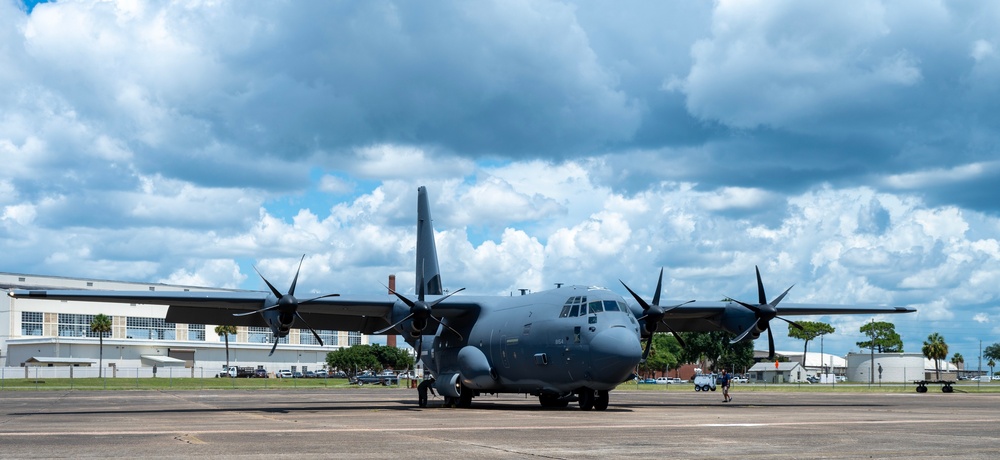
[8,289,478,334]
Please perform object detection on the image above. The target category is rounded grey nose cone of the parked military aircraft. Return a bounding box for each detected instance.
[590,327,642,388]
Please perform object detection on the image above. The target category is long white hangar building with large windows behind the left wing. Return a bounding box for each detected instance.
[0,273,368,377]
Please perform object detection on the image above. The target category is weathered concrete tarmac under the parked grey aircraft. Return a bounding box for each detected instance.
[0,388,1000,459]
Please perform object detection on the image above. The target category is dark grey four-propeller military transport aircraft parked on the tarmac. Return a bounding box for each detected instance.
[9,187,915,410]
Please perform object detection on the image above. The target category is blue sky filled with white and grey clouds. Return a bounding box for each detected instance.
[0,0,1000,363]
